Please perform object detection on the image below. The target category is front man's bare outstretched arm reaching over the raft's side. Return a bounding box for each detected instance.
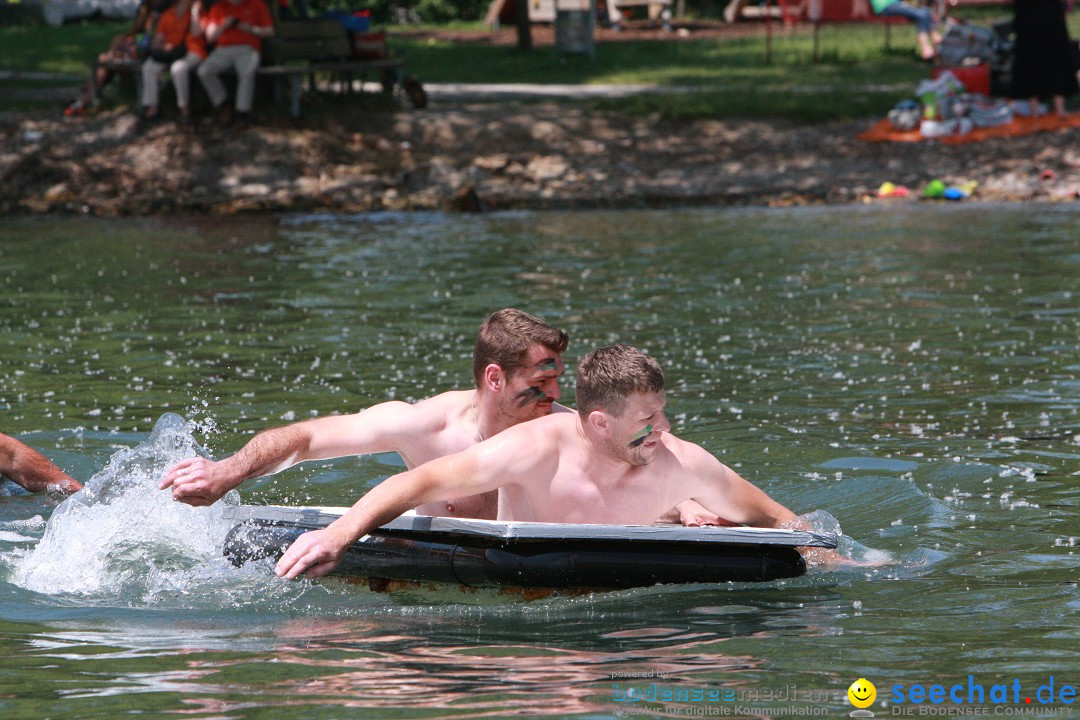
[274,431,543,580]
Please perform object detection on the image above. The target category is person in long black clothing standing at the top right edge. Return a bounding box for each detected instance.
[1012,0,1080,117]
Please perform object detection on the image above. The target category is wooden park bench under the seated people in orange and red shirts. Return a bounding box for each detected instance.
[91,19,405,118]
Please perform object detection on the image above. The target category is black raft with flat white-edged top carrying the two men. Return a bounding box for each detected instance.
[225,505,837,590]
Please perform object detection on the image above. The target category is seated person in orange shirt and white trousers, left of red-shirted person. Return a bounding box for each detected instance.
[141,0,206,127]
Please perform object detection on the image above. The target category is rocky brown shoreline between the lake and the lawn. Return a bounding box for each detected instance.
[0,103,1080,216]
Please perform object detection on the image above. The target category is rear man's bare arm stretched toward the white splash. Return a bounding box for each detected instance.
[160,400,440,506]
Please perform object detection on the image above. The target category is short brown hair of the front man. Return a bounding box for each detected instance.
[575,344,664,418]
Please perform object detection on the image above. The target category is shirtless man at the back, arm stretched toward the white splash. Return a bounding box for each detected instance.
[161,308,721,525]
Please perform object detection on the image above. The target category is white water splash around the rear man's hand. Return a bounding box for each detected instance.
[12,413,240,604]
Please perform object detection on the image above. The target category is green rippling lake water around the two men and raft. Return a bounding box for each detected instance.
[0,205,1080,719]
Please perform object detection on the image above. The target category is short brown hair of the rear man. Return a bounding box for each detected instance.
[473,308,570,388]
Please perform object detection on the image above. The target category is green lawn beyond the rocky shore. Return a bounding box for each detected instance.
[0,10,1080,122]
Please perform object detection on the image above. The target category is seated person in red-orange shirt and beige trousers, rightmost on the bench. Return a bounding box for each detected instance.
[198,0,273,125]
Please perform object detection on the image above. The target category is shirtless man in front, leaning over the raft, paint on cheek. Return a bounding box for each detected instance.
[274,345,795,579]
